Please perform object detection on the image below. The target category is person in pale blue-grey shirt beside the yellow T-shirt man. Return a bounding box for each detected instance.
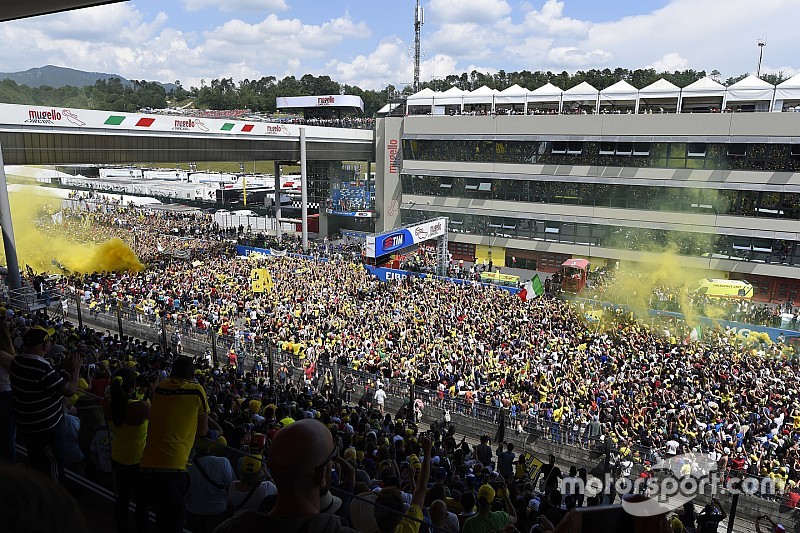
[186,439,236,533]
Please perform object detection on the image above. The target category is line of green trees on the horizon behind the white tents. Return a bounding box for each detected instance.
[0,68,786,116]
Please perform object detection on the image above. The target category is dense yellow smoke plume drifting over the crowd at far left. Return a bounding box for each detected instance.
[2,187,144,273]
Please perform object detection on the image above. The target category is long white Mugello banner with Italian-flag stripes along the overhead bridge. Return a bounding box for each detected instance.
[0,104,372,140]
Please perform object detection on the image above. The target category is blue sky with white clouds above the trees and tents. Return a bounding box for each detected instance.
[0,0,800,89]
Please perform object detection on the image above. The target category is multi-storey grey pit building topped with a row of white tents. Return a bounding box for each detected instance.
[376,76,800,303]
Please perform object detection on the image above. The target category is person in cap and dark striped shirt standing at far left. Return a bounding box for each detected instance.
[9,326,81,481]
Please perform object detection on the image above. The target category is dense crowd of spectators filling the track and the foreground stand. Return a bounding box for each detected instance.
[7,197,800,531]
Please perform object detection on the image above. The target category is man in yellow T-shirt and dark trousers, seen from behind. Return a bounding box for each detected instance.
[139,357,211,533]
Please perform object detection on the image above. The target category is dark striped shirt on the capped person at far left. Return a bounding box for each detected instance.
[10,354,67,433]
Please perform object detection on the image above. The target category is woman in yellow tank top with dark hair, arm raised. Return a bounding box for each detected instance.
[105,367,155,533]
